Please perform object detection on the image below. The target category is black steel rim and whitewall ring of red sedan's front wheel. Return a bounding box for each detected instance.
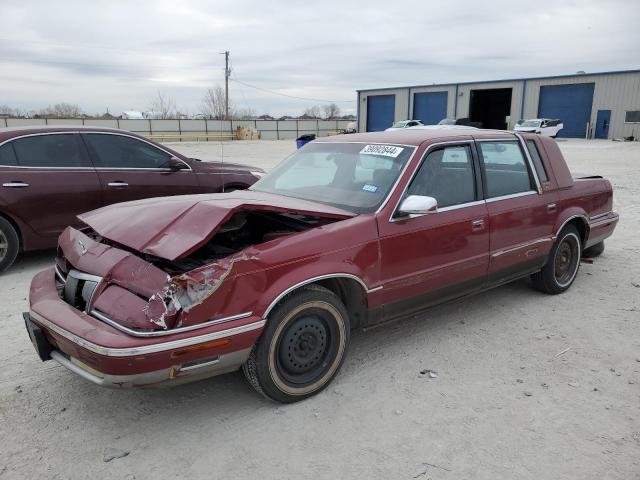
[269,301,346,395]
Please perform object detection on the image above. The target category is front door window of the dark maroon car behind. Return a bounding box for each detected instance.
[83,133,171,168]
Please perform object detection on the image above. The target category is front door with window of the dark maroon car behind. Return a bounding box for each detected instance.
[82,132,200,205]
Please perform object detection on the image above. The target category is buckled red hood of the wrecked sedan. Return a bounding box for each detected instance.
[78,190,356,260]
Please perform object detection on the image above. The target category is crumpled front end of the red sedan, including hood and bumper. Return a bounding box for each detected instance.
[24,194,350,387]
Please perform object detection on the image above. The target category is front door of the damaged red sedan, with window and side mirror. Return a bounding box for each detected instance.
[378,142,489,318]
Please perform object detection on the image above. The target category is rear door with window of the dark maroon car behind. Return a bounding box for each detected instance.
[0,132,101,242]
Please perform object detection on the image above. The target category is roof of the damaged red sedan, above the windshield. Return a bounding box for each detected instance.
[315,128,516,146]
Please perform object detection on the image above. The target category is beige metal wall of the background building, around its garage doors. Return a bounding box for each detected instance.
[358,71,640,138]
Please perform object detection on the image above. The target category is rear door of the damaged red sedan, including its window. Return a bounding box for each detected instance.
[476,139,557,283]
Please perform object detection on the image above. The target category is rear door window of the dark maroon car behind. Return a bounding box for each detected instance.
[12,133,87,168]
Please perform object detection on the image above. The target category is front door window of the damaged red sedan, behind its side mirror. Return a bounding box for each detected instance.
[407,146,476,207]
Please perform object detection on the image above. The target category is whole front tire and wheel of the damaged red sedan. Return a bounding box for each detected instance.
[243,285,350,403]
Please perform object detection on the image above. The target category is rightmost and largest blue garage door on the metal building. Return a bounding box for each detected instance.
[538,83,594,138]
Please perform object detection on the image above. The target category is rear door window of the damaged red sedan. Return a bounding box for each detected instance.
[478,142,535,198]
